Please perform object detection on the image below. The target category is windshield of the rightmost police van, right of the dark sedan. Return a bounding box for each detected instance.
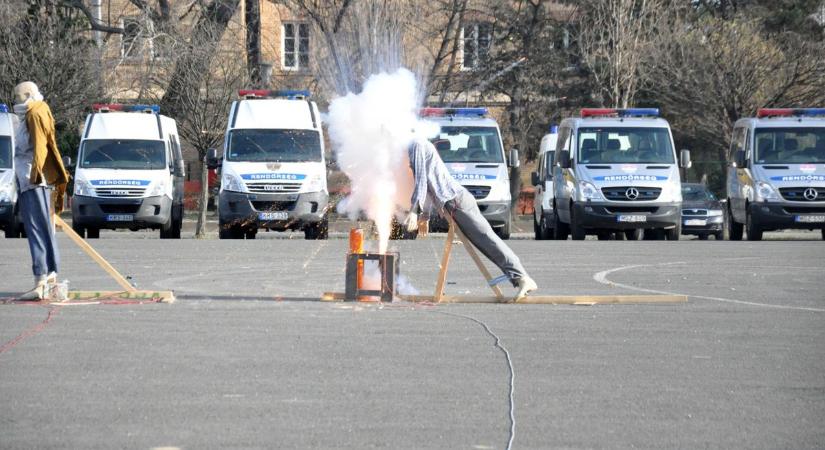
[756,127,825,164]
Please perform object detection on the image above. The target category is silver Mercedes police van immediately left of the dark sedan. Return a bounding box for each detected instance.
[553,108,690,240]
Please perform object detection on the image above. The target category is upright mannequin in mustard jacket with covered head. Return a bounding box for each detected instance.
[13,81,69,300]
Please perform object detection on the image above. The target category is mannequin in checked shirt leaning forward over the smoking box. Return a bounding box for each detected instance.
[406,140,537,301]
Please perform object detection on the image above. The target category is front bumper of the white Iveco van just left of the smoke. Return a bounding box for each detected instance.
[218,191,329,231]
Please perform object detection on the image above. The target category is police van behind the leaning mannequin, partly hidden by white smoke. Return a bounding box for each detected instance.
[421,108,518,239]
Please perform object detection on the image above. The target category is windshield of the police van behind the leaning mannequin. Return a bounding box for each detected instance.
[432,127,504,163]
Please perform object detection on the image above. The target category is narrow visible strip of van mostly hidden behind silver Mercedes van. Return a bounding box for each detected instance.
[530,125,559,240]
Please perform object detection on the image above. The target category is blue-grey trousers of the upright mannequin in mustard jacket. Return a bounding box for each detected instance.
[18,186,60,276]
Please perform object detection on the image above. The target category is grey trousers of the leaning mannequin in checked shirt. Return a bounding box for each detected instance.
[444,189,527,286]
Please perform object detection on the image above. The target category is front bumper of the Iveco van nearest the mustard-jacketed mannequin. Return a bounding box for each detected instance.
[72,195,172,230]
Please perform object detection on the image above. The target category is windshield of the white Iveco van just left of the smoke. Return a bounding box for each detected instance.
[226,130,322,162]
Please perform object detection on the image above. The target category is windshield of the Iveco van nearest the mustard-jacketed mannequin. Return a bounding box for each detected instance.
[80,139,166,170]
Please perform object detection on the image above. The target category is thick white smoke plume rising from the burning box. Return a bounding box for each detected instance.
[327,69,438,253]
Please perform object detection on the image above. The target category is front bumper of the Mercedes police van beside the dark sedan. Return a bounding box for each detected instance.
[573,202,682,230]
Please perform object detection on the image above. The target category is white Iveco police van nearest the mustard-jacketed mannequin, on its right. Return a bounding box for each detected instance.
[72,104,184,239]
